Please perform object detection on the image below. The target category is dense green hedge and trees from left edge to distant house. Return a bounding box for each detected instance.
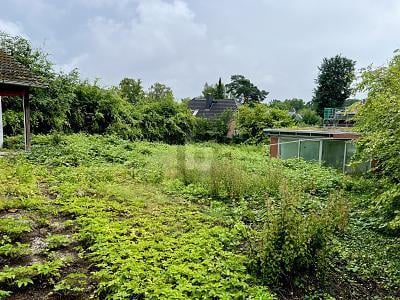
[0,33,194,144]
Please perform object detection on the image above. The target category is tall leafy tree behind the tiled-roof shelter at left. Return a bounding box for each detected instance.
[0,32,74,134]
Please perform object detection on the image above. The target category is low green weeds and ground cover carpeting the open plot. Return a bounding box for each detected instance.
[0,135,400,299]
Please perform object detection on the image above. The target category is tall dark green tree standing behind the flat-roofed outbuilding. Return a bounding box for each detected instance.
[312,55,356,116]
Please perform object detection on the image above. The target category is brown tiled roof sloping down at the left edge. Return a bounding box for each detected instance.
[0,49,45,87]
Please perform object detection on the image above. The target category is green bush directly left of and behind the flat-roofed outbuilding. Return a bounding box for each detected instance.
[237,104,294,143]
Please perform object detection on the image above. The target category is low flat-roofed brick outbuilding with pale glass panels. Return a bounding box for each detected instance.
[265,128,371,173]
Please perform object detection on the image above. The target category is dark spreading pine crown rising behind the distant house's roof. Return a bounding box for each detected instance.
[226,75,268,104]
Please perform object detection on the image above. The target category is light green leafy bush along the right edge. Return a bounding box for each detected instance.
[356,52,400,234]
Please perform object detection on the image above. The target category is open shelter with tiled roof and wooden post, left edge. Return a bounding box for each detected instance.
[0,50,45,150]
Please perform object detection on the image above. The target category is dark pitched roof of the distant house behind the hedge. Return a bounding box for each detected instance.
[188,98,238,119]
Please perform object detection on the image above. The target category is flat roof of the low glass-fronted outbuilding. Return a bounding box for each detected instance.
[265,128,360,140]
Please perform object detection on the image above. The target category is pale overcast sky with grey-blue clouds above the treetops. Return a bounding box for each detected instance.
[0,0,400,101]
